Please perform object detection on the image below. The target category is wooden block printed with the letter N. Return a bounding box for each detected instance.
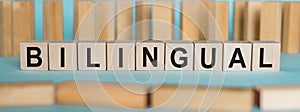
[135,40,165,70]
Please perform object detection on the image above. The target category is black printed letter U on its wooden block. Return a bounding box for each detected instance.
[201,48,216,68]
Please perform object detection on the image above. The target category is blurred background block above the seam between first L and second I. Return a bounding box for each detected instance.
[95,0,116,40]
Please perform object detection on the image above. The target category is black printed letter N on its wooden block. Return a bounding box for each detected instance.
[143,47,157,67]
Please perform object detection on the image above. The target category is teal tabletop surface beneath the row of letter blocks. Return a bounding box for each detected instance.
[0,54,300,112]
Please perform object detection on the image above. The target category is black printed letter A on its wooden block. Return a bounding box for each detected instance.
[229,48,246,68]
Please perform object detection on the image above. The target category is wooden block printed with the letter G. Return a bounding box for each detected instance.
[165,40,194,71]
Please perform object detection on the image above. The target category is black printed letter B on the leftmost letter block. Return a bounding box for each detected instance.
[27,47,43,67]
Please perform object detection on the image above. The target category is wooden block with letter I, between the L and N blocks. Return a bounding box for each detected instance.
[106,40,135,70]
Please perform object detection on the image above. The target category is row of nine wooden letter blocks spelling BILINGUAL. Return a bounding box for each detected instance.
[20,40,281,71]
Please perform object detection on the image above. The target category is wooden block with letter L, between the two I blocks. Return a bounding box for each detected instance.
[77,41,106,70]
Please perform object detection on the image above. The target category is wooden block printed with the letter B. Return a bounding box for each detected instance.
[20,41,48,70]
